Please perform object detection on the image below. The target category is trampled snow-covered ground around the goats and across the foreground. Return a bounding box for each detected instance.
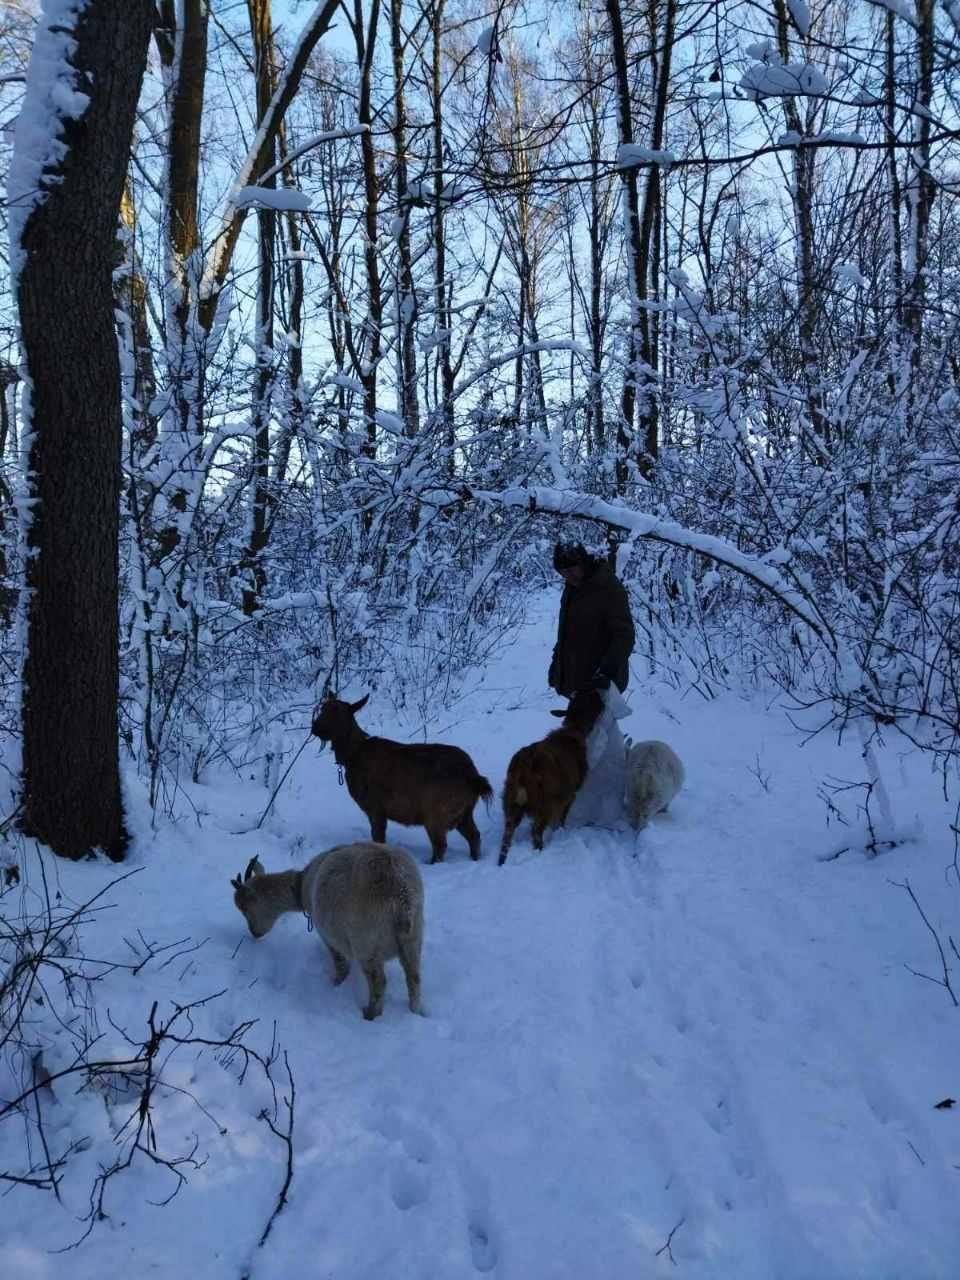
[0,601,960,1280]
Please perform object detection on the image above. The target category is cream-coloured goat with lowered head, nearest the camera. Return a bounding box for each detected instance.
[230,841,424,1021]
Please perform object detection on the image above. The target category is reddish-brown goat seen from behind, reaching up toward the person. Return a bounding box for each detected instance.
[497,689,603,867]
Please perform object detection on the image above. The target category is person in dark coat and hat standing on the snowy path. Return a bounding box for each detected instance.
[548,541,634,698]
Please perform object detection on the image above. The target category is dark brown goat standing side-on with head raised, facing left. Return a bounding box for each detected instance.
[314,694,493,863]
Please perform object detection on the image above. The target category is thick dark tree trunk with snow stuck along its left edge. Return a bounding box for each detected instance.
[17,0,154,859]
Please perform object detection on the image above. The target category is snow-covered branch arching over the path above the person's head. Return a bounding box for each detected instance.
[468,486,837,654]
